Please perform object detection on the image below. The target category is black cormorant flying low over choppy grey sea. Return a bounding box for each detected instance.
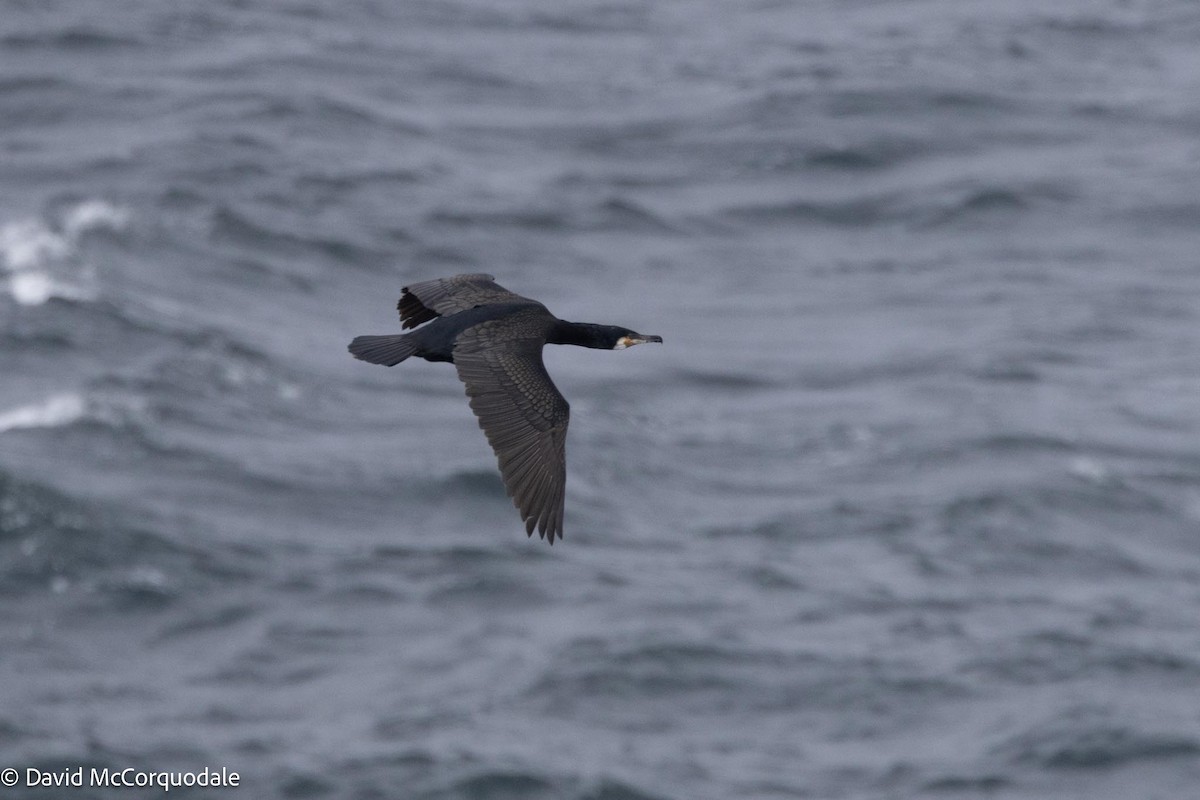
[349,275,662,545]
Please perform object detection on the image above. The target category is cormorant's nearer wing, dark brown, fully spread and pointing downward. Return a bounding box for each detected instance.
[454,309,571,545]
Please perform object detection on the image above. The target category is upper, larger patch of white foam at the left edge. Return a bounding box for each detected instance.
[0,199,130,306]
